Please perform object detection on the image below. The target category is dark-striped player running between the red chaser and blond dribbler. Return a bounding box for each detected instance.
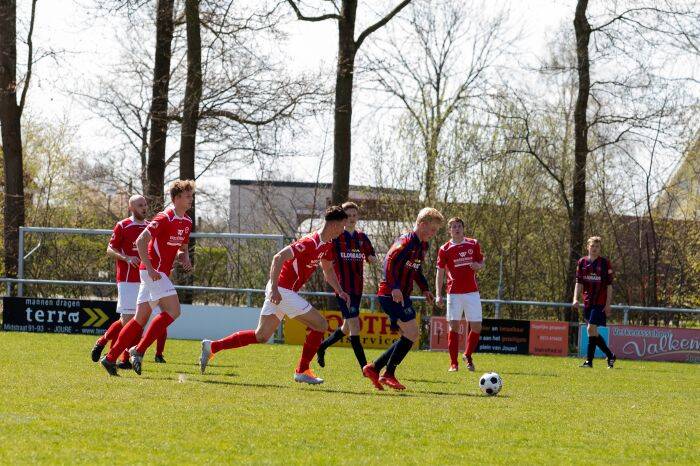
[316,202,377,370]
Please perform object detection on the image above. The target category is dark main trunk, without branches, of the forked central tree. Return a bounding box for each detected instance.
[331,0,357,205]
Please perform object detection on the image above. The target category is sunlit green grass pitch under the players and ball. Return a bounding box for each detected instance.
[0,333,700,465]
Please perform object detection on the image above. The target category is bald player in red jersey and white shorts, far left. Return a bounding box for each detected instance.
[91,195,167,369]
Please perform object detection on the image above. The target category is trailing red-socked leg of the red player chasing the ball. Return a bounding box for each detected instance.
[199,283,284,374]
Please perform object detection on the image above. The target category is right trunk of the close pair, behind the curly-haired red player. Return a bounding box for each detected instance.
[180,0,202,304]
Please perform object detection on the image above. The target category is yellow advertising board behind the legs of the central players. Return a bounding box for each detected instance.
[284,311,420,348]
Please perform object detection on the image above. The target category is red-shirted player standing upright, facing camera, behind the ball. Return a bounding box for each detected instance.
[435,217,484,372]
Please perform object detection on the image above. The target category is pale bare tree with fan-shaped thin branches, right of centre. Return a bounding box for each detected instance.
[371,2,508,205]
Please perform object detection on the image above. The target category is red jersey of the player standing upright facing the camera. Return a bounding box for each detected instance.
[437,238,484,294]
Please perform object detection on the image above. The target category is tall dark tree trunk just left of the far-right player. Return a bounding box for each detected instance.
[566,0,591,321]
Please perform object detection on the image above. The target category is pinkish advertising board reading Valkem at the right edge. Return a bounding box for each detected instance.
[608,325,700,362]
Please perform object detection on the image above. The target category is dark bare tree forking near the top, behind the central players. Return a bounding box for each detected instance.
[287,0,411,204]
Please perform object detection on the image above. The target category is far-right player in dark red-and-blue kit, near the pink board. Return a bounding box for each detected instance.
[572,236,617,369]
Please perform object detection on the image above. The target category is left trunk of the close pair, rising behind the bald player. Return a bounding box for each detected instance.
[146,0,174,212]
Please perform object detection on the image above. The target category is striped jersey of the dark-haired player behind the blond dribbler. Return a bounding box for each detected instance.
[333,231,376,294]
